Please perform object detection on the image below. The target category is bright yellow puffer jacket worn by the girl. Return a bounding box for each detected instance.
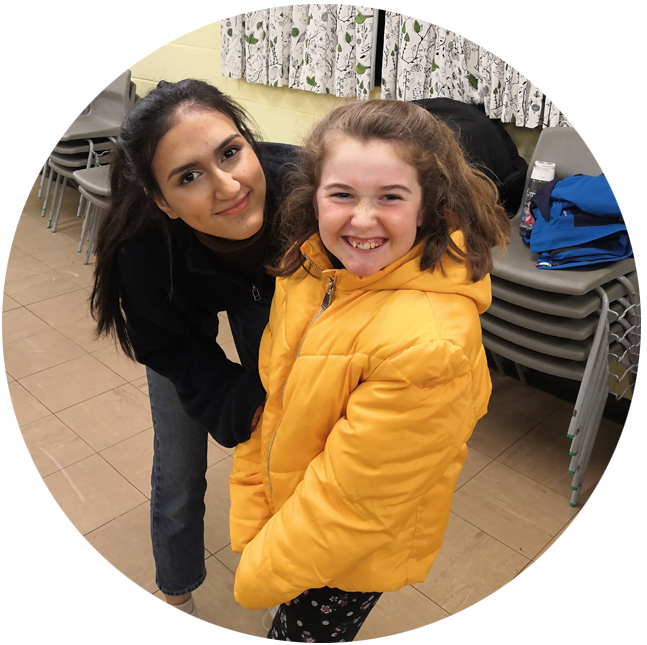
[230,233,491,609]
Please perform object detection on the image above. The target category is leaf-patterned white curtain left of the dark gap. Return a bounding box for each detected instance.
[221,4,378,99]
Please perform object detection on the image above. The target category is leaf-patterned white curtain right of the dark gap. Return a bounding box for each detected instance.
[382,11,571,128]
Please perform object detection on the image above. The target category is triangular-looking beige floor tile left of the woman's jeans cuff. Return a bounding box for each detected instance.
[84,501,157,594]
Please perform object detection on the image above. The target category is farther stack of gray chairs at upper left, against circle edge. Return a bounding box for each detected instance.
[38,70,134,240]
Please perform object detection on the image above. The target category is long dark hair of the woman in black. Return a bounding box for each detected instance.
[90,79,259,359]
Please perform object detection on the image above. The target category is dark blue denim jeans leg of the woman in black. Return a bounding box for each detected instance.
[146,368,208,596]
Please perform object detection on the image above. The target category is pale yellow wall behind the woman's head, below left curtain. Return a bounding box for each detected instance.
[130,21,380,144]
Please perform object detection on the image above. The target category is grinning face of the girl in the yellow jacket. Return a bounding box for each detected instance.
[315,135,422,277]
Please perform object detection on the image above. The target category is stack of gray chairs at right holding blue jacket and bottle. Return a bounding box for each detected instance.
[481,128,641,506]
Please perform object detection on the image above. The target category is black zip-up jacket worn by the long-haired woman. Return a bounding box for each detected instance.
[118,144,296,447]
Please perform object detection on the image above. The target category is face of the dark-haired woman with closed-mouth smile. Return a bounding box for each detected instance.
[152,109,265,240]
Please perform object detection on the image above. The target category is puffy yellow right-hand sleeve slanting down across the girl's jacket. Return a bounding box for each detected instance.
[234,341,476,609]
